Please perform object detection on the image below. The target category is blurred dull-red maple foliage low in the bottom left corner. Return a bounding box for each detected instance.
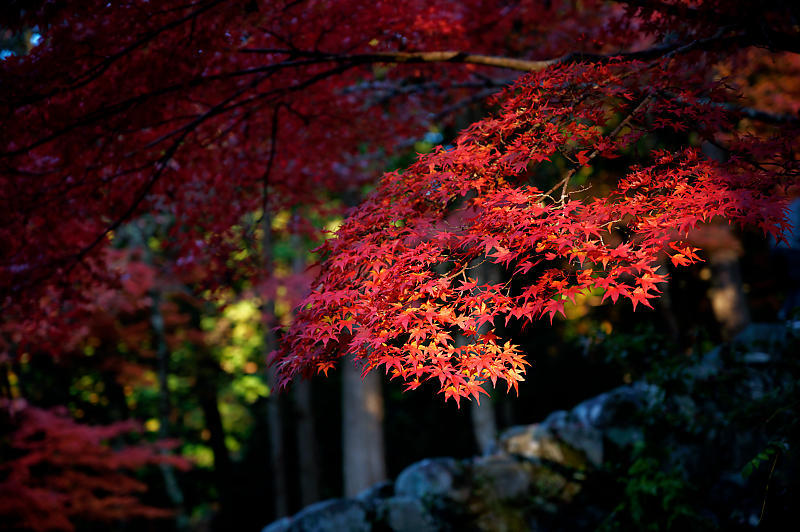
[0,399,188,531]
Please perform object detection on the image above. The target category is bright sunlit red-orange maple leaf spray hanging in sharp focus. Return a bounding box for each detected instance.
[273,11,800,402]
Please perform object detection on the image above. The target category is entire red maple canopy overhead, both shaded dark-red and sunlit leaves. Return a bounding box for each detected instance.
[0,0,800,394]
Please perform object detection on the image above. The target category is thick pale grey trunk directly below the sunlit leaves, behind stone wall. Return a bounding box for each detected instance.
[341,358,386,497]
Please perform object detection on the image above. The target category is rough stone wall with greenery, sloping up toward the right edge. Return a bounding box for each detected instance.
[263,323,800,532]
